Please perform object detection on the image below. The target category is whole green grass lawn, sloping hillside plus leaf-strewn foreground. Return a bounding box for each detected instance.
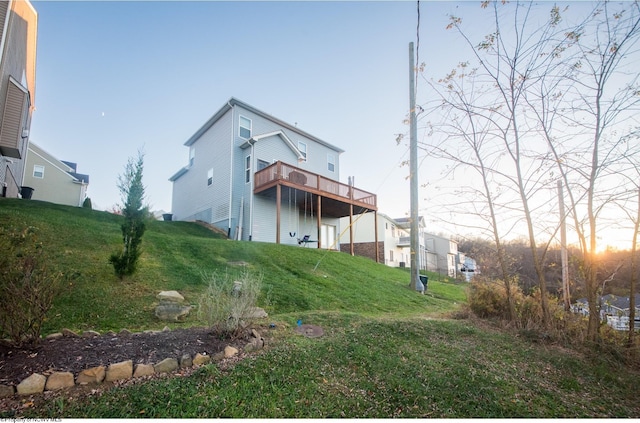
[0,199,640,418]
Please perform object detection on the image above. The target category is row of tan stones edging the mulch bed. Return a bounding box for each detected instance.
[0,328,265,398]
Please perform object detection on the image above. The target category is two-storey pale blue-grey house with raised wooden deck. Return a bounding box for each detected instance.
[169,98,377,249]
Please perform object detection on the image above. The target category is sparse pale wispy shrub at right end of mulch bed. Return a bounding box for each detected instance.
[198,272,262,338]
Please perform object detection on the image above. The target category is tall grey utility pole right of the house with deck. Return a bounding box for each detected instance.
[409,42,424,293]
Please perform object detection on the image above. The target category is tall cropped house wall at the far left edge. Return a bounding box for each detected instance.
[0,0,38,197]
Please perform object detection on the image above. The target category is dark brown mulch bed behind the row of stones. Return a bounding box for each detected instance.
[0,328,244,386]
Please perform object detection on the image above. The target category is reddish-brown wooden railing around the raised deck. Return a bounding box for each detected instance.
[254,161,377,208]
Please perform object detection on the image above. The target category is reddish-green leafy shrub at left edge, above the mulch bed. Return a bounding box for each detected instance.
[0,227,62,346]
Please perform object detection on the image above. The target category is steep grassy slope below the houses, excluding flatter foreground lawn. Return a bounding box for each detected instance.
[0,198,465,334]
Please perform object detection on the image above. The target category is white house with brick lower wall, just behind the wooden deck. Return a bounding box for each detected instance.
[340,213,410,267]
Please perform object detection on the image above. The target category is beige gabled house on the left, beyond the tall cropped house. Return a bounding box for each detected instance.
[23,142,89,206]
